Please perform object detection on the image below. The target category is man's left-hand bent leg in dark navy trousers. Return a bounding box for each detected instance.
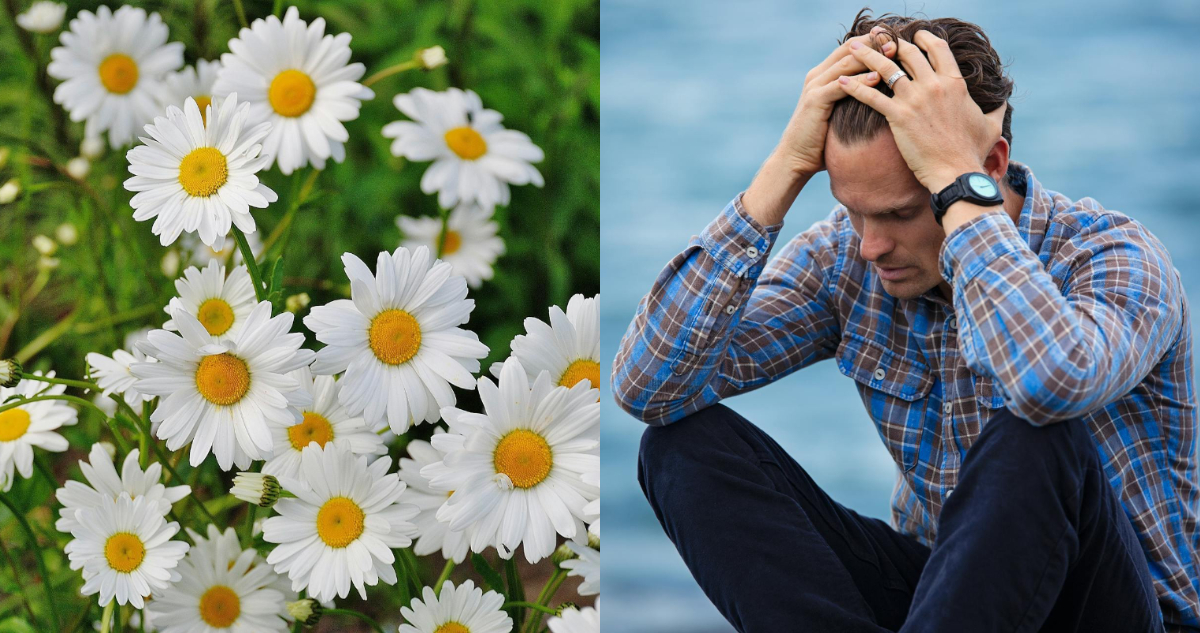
[637,405,929,633]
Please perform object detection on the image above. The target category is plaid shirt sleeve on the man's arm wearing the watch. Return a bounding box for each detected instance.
[941,210,1184,424]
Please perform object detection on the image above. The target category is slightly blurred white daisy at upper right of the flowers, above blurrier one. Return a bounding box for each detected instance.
[383,88,545,209]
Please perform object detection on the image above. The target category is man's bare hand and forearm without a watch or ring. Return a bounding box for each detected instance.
[742,31,895,227]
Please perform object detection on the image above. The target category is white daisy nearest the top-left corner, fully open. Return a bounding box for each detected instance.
[46,6,184,149]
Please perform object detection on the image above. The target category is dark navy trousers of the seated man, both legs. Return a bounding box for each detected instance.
[637,405,1163,633]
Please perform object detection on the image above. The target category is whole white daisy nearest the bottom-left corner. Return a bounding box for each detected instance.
[65,492,187,609]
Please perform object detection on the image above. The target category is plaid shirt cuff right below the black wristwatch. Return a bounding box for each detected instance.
[938,210,1028,285]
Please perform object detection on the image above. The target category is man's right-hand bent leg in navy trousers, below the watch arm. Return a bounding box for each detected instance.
[901,410,1163,633]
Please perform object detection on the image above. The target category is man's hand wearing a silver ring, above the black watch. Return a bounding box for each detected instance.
[838,30,1007,192]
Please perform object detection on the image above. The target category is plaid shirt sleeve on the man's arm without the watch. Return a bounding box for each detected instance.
[612,194,839,426]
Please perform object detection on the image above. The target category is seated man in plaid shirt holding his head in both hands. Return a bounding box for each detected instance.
[612,8,1200,633]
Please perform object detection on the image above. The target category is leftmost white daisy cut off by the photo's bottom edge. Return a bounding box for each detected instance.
[146,525,295,633]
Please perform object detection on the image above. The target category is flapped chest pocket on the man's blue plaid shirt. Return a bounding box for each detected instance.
[836,332,934,472]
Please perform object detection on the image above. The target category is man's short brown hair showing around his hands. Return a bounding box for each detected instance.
[829,8,1013,154]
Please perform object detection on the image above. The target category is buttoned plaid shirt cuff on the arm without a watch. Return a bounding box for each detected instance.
[700,192,784,279]
